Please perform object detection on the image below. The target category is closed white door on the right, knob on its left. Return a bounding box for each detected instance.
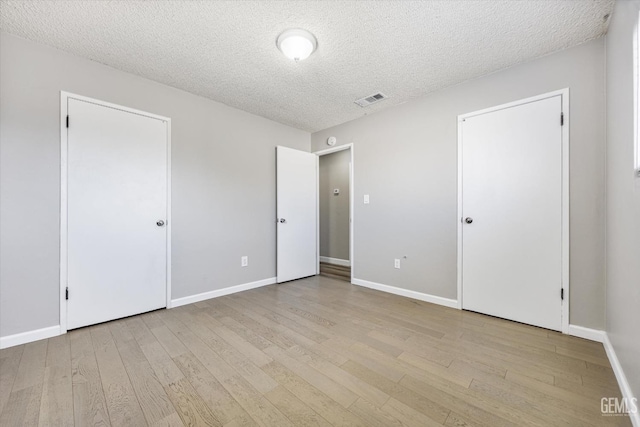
[461,95,562,330]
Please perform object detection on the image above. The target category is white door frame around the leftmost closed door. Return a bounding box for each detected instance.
[60,91,172,334]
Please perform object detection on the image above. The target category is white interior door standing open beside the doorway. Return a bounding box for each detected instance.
[276,147,318,283]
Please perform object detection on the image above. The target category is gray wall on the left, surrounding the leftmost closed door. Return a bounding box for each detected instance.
[0,34,310,336]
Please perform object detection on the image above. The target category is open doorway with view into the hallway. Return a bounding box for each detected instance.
[316,144,353,283]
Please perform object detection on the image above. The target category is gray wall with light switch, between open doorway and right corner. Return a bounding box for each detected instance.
[311,39,605,329]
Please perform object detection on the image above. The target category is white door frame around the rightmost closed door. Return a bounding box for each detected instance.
[458,88,570,334]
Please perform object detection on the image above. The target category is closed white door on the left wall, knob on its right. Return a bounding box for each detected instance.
[67,98,168,329]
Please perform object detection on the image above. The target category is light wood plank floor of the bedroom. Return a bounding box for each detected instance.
[0,277,630,427]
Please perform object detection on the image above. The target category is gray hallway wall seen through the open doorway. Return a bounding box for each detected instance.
[319,150,351,260]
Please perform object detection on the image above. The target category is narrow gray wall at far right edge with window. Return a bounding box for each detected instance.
[607,1,640,398]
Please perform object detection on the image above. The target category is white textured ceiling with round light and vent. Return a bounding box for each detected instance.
[0,0,613,131]
